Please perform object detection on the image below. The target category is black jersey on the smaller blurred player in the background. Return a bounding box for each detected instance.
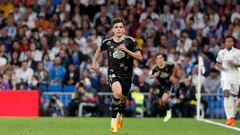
[152,63,174,85]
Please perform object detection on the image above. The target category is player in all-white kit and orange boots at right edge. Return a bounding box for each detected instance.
[216,36,240,126]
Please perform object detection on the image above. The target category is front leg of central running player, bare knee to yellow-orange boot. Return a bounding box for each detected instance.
[110,81,122,133]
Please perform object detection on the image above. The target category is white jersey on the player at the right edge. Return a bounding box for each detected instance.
[216,47,240,83]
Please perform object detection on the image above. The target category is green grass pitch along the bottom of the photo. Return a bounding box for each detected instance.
[0,117,240,135]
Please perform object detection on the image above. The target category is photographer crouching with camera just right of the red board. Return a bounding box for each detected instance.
[44,94,64,117]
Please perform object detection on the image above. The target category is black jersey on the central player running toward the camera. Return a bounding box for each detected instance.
[100,37,139,77]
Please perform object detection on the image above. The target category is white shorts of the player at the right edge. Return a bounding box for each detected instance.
[221,81,239,95]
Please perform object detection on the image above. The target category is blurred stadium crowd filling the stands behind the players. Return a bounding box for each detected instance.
[0,0,240,117]
